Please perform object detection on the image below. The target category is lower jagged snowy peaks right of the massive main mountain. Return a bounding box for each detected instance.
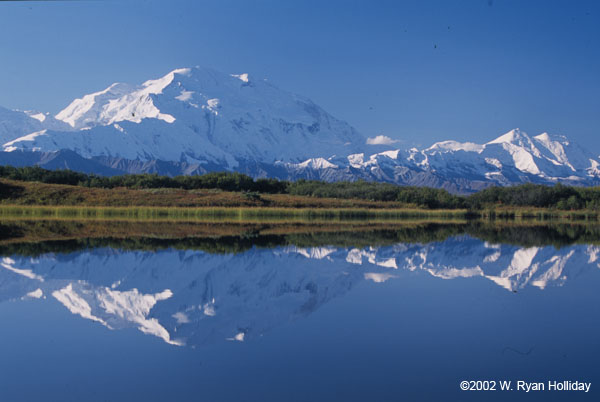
[282,129,600,192]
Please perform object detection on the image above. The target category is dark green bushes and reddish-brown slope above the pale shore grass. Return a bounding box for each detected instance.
[0,166,600,214]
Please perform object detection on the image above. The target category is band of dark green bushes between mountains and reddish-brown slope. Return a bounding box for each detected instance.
[0,166,600,210]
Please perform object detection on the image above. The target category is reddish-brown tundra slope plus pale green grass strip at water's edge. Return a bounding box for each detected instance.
[0,179,600,222]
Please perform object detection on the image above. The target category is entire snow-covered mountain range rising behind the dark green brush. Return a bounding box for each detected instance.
[0,67,600,193]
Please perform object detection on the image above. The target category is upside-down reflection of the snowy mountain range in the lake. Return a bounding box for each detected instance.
[0,235,600,346]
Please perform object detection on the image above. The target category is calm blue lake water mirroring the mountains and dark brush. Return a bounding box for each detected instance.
[0,228,600,401]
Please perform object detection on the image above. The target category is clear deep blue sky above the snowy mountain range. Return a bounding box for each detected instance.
[0,0,600,149]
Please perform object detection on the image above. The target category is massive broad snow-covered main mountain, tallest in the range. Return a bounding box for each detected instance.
[4,67,365,169]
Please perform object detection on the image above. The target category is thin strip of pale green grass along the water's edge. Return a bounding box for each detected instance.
[0,204,600,223]
